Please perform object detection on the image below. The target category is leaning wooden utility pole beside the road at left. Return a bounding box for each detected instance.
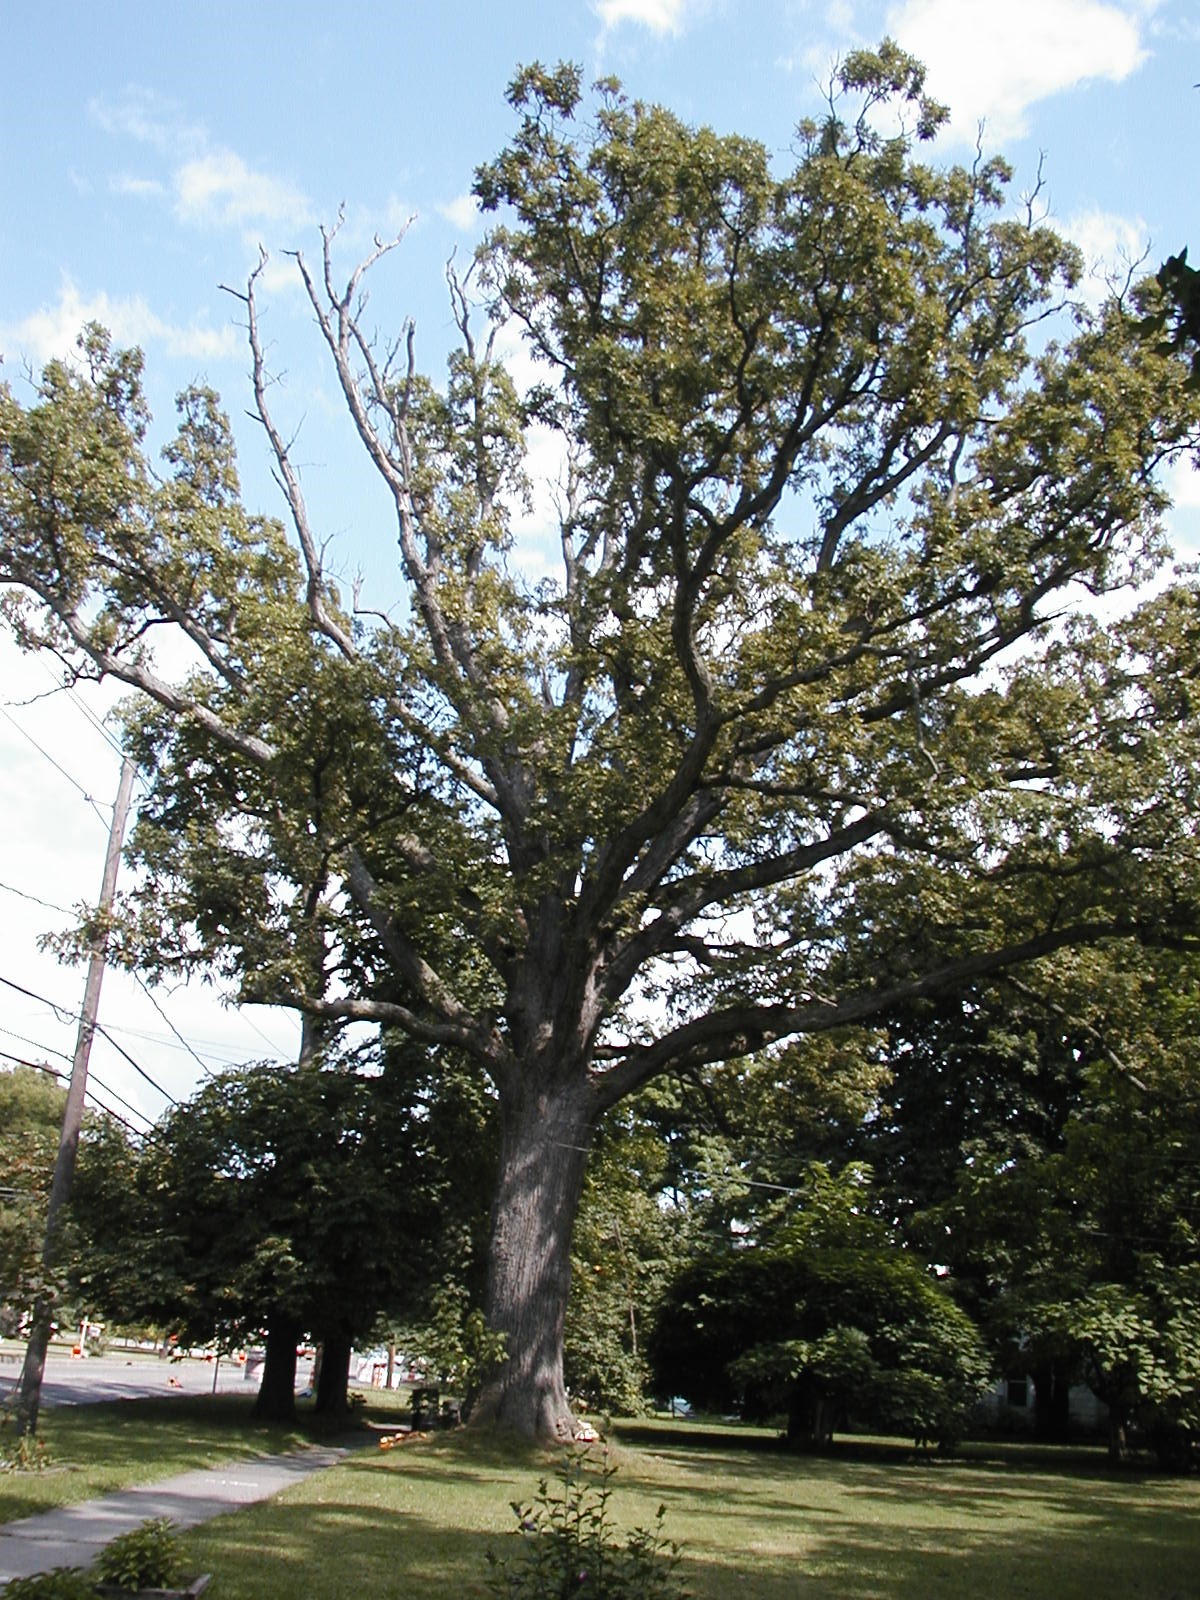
[16,755,136,1438]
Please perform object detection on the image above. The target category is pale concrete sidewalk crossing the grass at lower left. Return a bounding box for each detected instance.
[0,1445,349,1584]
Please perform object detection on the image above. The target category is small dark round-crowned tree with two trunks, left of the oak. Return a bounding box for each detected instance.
[75,1051,486,1418]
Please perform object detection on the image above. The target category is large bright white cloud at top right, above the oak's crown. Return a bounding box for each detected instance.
[888,0,1147,144]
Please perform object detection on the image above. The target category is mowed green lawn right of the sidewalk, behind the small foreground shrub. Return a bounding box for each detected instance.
[171,1424,1200,1600]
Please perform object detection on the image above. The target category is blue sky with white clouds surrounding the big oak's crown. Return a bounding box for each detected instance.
[0,0,1200,1115]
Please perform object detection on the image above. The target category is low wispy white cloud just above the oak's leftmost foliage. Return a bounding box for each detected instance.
[0,278,242,366]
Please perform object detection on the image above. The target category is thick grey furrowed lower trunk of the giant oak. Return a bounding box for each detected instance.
[470,1083,594,1442]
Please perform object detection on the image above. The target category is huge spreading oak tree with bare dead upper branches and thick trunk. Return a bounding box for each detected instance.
[0,43,1197,1435]
